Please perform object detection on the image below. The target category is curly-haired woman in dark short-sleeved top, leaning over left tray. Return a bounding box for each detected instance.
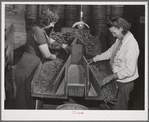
[14,9,67,109]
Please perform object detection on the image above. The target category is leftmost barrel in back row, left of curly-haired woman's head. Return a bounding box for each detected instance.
[26,5,38,20]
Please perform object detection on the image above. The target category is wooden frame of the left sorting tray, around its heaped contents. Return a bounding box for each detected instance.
[32,59,69,99]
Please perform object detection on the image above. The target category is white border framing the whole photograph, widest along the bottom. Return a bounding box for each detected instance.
[1,1,149,121]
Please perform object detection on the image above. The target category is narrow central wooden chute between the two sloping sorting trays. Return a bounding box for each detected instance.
[66,44,87,97]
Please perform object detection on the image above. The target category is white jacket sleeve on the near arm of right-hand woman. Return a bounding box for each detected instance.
[117,46,139,80]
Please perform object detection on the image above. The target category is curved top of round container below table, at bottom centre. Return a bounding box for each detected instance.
[56,104,89,110]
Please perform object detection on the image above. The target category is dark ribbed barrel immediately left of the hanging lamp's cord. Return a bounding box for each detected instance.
[65,5,79,27]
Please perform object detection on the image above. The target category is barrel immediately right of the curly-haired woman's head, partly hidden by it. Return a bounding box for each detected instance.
[53,5,65,32]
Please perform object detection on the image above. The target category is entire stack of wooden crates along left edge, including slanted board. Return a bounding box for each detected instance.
[5,6,26,100]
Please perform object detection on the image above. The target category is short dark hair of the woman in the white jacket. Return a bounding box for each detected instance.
[107,16,131,35]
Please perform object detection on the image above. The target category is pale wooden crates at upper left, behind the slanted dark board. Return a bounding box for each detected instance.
[5,4,26,65]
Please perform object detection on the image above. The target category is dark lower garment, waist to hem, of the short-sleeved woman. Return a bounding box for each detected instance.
[14,53,40,109]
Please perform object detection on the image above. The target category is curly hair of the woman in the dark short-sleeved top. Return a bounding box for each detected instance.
[38,8,59,27]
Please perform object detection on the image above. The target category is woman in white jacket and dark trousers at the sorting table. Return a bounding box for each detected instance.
[88,17,139,110]
